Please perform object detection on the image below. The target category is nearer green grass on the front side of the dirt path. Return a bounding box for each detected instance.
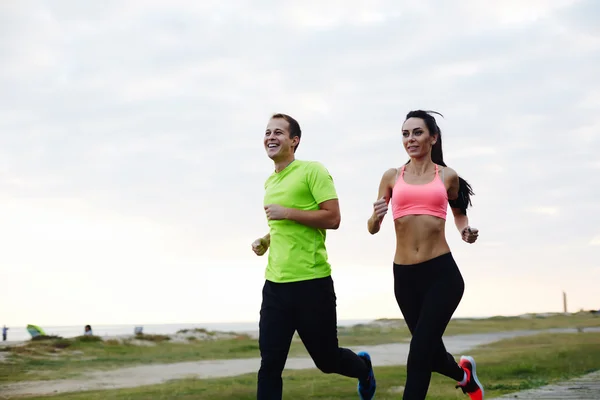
[21,333,600,400]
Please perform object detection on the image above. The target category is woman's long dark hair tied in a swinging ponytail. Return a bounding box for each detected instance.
[405,110,475,215]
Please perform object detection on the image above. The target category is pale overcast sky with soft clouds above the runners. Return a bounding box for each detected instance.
[0,0,600,326]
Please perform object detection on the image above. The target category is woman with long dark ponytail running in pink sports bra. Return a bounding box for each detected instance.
[368,110,483,400]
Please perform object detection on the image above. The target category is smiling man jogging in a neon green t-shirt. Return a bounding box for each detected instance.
[252,114,376,400]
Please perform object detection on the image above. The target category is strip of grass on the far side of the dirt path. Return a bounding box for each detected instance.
[0,313,600,383]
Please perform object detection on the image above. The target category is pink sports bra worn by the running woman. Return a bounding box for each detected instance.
[391,164,448,220]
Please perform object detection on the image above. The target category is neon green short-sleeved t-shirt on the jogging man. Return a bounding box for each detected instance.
[264,160,337,283]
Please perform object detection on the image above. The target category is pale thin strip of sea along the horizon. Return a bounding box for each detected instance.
[7,319,372,342]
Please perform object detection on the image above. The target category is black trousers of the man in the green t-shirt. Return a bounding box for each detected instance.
[257,277,369,400]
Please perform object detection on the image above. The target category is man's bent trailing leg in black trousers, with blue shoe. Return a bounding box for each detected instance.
[294,277,375,399]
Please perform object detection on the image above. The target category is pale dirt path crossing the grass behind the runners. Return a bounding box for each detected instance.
[0,329,587,398]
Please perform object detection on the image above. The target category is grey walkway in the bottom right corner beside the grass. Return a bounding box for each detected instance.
[492,366,600,400]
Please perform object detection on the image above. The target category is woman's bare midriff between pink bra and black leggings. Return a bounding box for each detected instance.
[394,215,450,265]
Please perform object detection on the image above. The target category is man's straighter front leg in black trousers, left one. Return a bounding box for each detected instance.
[256,281,295,400]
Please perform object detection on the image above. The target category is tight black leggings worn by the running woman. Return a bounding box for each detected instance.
[394,253,465,400]
